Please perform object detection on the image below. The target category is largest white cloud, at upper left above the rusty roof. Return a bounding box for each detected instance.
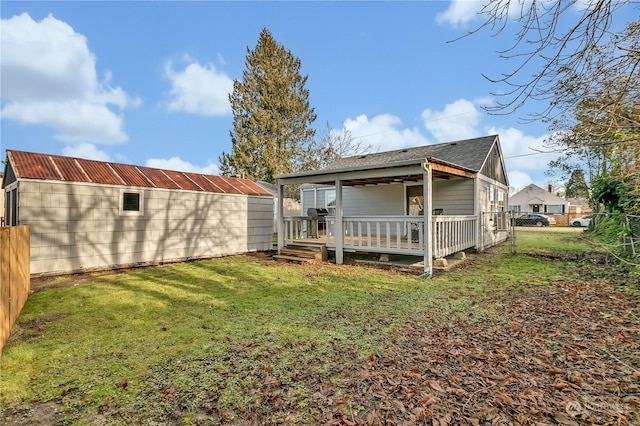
[0,13,140,143]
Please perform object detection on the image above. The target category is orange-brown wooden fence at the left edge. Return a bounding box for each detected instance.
[0,225,31,354]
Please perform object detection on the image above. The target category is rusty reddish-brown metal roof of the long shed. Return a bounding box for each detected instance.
[7,149,271,197]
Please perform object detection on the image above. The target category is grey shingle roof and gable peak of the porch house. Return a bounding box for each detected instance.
[324,135,498,172]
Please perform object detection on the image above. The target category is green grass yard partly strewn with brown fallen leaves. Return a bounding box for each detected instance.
[0,231,640,425]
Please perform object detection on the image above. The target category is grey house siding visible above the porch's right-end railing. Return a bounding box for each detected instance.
[433,179,474,215]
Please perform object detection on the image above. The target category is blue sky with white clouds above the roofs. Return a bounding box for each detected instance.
[0,0,637,190]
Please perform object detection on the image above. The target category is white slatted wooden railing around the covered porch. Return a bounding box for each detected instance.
[284,216,478,258]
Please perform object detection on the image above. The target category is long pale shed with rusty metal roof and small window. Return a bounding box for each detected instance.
[2,150,274,275]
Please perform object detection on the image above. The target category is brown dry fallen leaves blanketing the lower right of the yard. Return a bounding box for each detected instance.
[150,281,640,425]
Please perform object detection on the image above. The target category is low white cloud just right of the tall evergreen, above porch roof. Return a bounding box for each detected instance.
[343,114,429,151]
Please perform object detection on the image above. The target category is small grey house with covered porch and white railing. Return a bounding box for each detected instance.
[277,135,509,276]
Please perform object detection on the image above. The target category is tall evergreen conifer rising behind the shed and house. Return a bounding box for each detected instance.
[219,28,316,183]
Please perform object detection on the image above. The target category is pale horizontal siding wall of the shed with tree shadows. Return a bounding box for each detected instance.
[19,181,273,274]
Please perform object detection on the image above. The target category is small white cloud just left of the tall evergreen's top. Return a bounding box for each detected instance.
[165,58,233,116]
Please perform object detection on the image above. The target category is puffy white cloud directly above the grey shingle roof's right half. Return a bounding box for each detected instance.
[422,99,481,142]
